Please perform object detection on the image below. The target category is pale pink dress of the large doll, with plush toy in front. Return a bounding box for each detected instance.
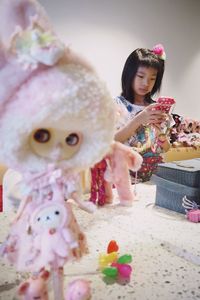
[1,166,87,272]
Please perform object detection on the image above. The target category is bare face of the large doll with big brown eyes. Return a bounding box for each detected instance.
[29,127,83,162]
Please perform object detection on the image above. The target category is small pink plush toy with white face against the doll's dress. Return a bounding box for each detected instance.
[24,201,86,271]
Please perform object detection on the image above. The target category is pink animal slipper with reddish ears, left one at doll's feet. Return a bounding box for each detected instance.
[17,270,50,300]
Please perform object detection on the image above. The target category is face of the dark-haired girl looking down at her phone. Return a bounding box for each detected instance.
[132,67,158,96]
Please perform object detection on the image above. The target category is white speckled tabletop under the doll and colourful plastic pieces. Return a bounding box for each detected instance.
[0,182,200,300]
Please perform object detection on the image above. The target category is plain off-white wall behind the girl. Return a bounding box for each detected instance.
[40,0,200,119]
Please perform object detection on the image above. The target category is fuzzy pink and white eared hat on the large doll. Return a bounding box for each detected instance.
[0,0,114,171]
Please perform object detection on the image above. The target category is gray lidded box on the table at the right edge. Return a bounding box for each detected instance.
[151,159,200,214]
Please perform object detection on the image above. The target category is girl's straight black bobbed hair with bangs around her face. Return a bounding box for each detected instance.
[121,48,165,103]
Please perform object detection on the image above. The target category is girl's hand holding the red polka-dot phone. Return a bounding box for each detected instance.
[137,104,168,125]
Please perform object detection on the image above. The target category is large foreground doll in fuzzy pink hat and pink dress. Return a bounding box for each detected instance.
[0,0,114,300]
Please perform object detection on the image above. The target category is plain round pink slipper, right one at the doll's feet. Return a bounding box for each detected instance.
[65,279,91,300]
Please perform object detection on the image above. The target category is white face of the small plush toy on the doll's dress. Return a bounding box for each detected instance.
[31,203,70,232]
